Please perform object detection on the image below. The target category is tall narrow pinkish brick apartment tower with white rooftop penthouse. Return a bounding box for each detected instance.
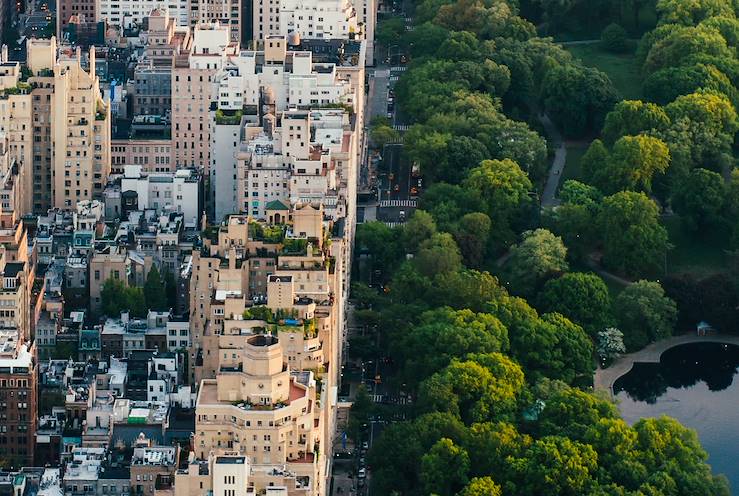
[172,24,238,175]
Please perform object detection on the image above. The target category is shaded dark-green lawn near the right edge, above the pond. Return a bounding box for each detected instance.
[662,215,729,276]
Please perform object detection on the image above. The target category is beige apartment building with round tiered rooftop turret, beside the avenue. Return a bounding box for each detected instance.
[194,335,326,495]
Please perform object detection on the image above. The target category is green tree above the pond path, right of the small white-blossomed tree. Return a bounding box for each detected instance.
[613,280,677,351]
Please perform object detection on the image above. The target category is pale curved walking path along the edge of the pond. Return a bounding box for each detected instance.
[593,332,739,396]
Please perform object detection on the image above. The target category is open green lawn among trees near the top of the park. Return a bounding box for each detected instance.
[565,43,642,100]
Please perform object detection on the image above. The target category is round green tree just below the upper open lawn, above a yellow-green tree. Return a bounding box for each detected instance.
[604,100,672,146]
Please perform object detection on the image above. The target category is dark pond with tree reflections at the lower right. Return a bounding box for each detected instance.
[613,343,739,495]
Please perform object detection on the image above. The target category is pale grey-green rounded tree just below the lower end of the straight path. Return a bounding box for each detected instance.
[504,229,568,295]
